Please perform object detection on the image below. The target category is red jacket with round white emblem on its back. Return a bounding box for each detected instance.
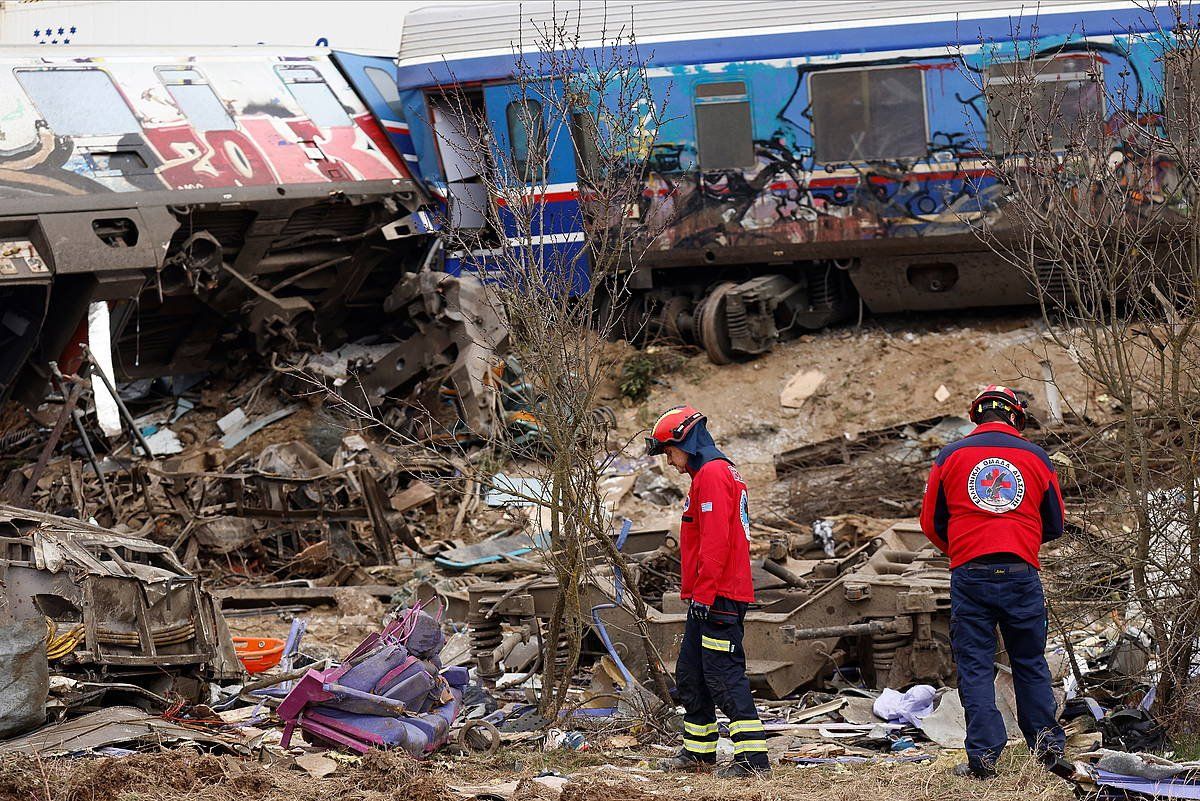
[920,423,1063,568]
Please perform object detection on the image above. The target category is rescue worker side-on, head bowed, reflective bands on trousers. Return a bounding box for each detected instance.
[646,406,770,777]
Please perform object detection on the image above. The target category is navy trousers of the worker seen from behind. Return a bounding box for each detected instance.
[950,565,1064,770]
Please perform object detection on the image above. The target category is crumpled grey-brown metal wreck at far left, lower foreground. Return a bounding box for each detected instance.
[0,506,240,677]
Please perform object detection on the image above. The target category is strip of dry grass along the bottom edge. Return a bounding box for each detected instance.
[0,748,1072,801]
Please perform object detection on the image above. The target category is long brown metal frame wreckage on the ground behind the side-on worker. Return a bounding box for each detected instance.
[460,515,954,698]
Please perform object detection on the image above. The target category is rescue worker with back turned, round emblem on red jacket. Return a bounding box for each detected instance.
[920,385,1070,778]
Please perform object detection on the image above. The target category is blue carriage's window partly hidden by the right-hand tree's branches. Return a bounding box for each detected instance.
[985,55,1104,152]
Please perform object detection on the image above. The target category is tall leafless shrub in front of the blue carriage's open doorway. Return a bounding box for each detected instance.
[304,1,681,713]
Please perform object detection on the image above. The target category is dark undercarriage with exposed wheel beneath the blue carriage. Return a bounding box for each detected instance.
[601,237,1041,365]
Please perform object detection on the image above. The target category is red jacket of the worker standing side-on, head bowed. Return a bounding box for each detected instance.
[679,459,754,604]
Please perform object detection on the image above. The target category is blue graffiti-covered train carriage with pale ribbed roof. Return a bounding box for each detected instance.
[352,0,1175,362]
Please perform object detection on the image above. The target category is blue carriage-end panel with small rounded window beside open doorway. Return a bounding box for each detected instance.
[484,84,590,294]
